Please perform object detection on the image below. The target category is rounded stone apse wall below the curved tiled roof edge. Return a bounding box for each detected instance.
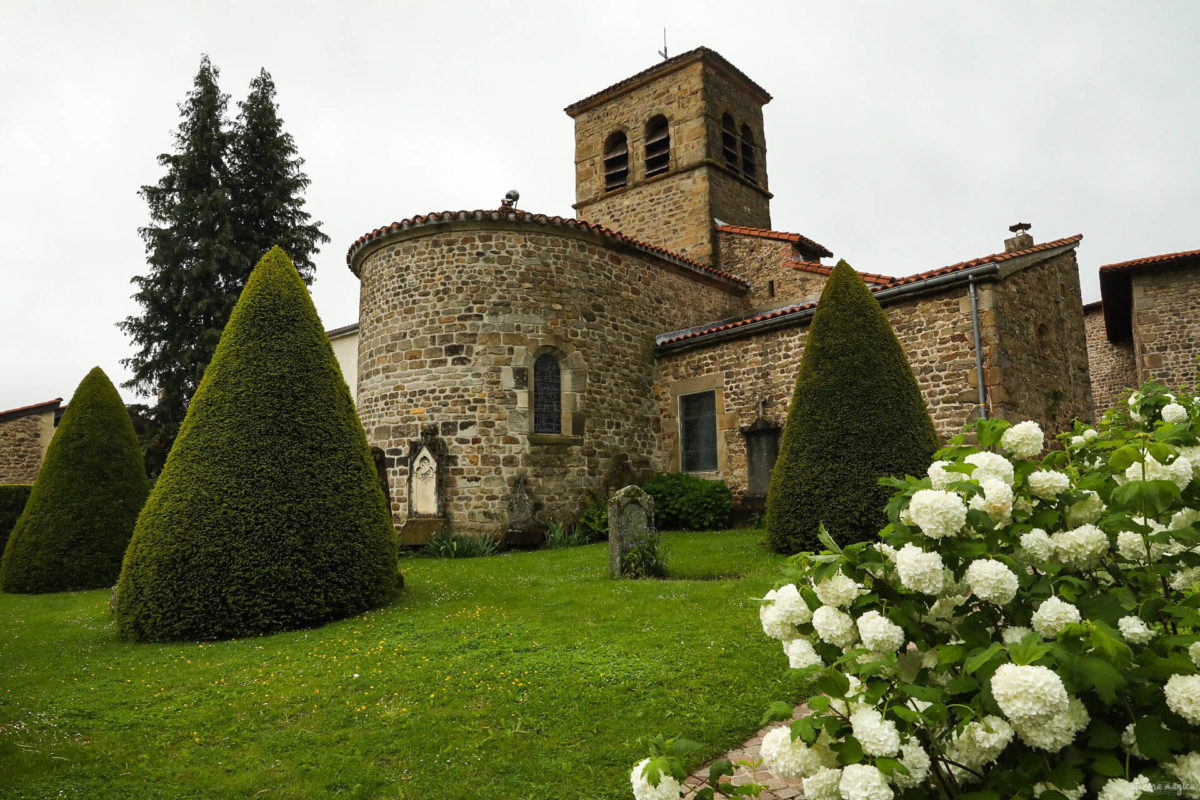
[356,222,743,534]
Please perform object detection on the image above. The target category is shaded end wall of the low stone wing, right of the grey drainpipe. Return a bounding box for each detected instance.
[984,249,1093,434]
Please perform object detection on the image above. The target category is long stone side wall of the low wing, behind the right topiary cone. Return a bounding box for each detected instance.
[655,288,990,497]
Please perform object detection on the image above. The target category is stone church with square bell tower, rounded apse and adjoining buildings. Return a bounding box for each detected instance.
[0,48,1200,541]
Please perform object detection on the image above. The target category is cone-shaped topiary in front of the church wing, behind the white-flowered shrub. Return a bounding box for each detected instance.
[767,261,937,553]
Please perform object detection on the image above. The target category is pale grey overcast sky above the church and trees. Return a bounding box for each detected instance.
[0,0,1200,410]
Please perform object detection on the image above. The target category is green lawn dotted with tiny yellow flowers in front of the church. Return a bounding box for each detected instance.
[0,530,803,800]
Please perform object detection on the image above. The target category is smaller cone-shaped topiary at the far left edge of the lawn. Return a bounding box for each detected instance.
[0,367,150,593]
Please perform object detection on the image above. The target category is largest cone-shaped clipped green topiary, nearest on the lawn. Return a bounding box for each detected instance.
[116,247,396,640]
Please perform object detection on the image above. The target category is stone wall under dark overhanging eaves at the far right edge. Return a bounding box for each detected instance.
[1133,265,1200,389]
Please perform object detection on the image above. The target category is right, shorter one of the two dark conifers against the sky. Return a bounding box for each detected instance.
[229,70,329,283]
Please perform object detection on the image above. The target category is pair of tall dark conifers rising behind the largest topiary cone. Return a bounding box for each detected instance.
[118,55,329,475]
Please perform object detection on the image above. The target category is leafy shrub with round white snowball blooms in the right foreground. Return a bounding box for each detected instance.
[635,384,1200,800]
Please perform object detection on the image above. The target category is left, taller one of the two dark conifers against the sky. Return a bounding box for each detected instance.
[118,55,236,473]
